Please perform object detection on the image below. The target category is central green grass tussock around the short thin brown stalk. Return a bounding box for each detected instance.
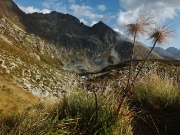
[58,91,132,135]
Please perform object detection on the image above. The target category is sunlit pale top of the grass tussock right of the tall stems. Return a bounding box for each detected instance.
[134,75,180,109]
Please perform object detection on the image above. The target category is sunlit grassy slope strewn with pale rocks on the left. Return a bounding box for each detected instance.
[0,17,77,99]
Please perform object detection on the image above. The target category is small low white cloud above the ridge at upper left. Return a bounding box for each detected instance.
[19,5,51,14]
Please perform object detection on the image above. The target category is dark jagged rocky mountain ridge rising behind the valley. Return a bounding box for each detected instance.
[0,0,161,72]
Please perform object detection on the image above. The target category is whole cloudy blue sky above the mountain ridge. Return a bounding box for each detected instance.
[14,0,180,49]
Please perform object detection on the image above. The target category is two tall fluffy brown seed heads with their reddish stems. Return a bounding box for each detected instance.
[117,14,174,116]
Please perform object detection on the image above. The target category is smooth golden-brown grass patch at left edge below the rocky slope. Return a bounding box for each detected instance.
[0,78,40,119]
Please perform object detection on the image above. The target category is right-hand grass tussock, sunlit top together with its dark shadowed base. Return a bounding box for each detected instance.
[131,75,180,135]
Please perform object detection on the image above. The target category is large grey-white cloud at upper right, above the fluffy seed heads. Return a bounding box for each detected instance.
[117,0,180,25]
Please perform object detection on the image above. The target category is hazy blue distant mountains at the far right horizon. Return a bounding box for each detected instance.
[154,47,180,60]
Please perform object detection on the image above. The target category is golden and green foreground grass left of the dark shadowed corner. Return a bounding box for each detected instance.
[0,77,132,135]
